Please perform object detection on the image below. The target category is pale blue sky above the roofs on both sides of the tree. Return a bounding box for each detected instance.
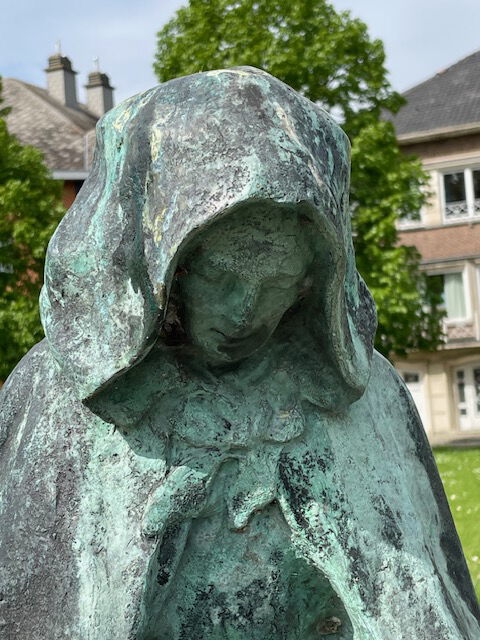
[0,0,480,103]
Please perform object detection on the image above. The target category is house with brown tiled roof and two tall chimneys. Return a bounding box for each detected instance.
[2,53,113,207]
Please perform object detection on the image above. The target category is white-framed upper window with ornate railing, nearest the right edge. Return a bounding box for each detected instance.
[443,168,480,222]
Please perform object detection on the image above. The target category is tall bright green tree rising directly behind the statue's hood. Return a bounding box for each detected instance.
[154,0,442,356]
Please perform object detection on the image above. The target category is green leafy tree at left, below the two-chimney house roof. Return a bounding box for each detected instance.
[0,83,63,380]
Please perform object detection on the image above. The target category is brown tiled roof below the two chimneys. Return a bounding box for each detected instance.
[2,78,98,177]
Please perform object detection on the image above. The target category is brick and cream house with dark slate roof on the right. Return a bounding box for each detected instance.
[392,51,480,443]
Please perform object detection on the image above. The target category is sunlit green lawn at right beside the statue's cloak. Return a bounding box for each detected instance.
[433,448,480,599]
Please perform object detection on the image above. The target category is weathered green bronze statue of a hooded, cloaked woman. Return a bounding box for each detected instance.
[0,68,480,640]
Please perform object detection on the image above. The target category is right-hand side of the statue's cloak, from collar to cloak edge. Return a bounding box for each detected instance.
[279,356,480,640]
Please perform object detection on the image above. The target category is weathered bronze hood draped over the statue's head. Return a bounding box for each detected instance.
[41,67,376,400]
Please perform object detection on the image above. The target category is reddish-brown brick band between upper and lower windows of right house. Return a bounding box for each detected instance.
[399,223,480,264]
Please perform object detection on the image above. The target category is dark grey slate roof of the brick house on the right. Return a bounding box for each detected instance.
[389,50,480,141]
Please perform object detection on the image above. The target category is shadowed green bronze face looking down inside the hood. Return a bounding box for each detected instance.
[178,206,312,364]
